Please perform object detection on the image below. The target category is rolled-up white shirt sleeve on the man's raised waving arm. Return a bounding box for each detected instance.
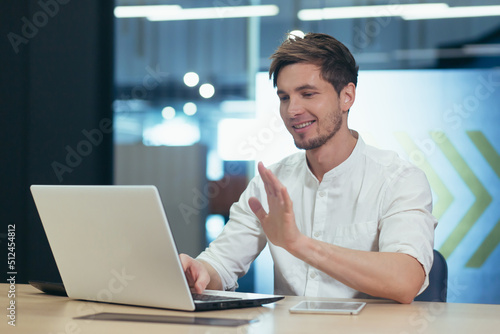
[379,167,437,294]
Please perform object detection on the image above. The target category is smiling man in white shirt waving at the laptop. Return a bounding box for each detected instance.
[181,33,437,303]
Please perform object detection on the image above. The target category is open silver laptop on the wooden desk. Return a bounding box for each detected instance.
[31,185,283,311]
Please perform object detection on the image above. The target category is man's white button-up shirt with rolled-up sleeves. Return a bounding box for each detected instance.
[198,137,437,298]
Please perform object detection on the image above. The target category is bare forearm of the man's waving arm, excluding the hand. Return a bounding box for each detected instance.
[288,236,425,303]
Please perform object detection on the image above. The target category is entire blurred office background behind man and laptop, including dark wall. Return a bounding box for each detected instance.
[0,0,500,303]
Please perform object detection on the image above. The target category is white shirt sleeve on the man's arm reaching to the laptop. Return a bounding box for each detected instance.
[197,177,267,290]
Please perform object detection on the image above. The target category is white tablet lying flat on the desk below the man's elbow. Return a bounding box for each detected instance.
[290,300,366,314]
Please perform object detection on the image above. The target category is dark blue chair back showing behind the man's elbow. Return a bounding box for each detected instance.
[415,250,448,302]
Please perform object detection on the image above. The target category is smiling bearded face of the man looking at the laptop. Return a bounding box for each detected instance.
[277,63,343,150]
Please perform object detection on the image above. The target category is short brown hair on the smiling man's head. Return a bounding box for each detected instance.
[269,33,359,94]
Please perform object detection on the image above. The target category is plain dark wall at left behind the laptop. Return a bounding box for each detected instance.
[0,0,113,283]
